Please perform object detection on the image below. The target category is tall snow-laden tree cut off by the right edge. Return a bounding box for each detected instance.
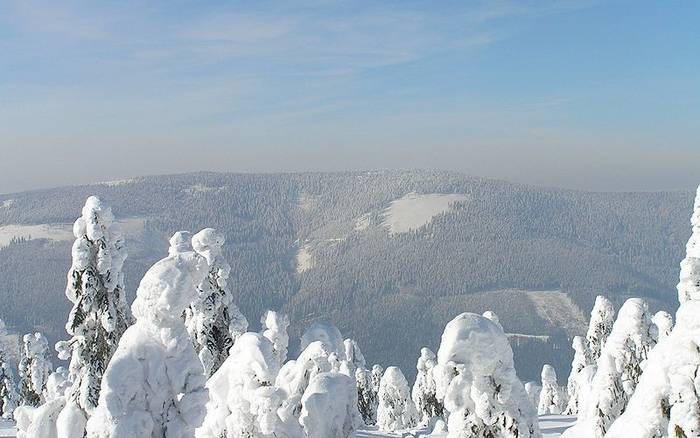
[606,187,700,438]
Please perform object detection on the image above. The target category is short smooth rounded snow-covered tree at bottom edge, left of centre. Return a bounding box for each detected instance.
[299,373,360,438]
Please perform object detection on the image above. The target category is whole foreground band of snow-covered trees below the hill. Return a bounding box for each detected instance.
[0,183,700,438]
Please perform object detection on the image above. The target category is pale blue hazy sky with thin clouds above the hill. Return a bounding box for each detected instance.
[0,0,700,193]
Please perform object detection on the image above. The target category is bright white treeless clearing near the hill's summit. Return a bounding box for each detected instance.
[382,193,469,234]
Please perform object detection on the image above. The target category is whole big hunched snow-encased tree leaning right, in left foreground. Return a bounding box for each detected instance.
[87,234,209,438]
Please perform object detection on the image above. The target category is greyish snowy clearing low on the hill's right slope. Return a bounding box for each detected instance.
[526,290,588,336]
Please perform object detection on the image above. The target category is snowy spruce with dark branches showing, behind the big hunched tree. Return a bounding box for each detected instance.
[185,228,248,376]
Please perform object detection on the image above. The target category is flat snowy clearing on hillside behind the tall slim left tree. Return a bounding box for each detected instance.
[0,218,145,248]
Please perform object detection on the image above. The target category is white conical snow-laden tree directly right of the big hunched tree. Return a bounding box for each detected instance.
[196,333,303,438]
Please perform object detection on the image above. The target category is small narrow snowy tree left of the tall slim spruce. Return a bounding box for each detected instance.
[19,333,52,406]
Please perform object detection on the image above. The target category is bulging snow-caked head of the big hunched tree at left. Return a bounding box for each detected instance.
[131,251,208,327]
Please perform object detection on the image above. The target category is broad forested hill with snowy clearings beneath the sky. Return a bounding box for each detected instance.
[0,170,693,383]
